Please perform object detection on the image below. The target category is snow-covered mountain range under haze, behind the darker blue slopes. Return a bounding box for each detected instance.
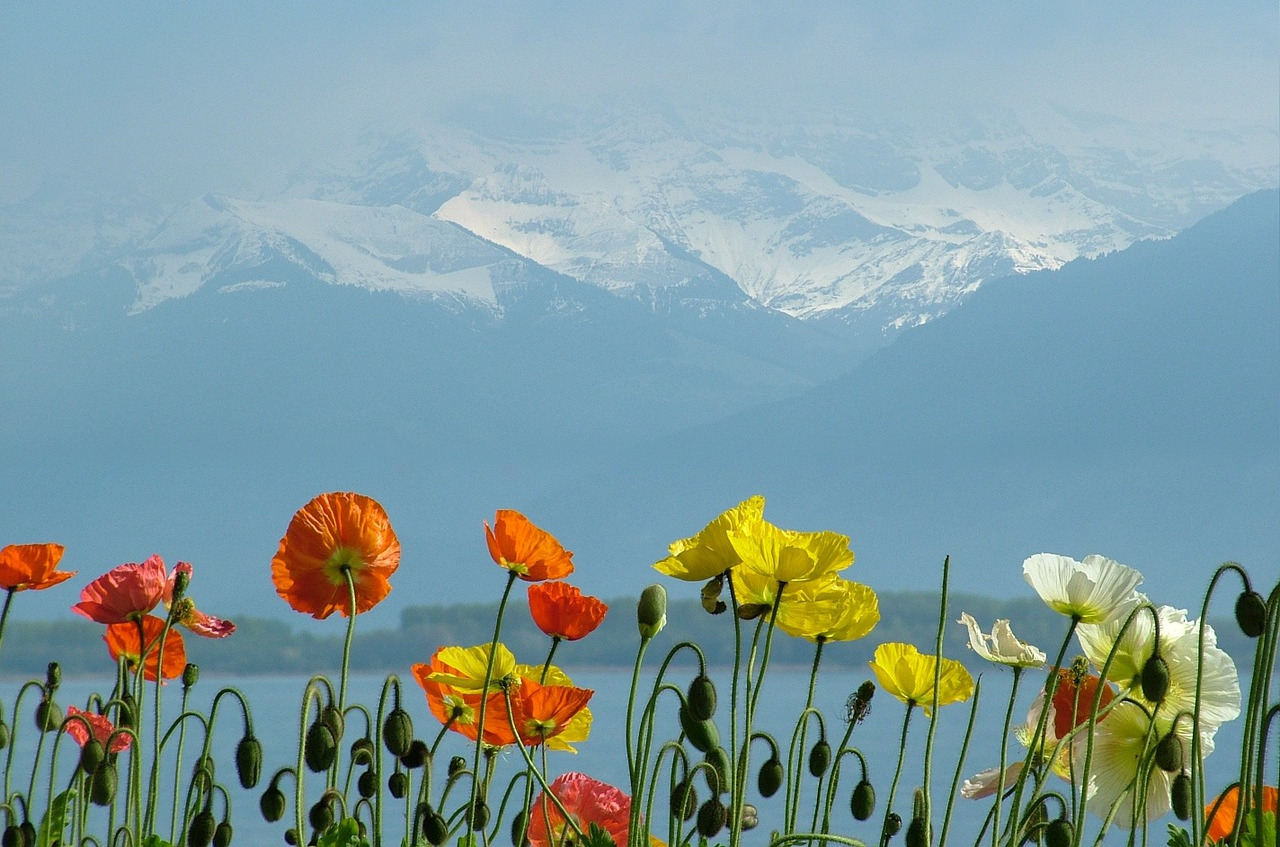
[4,102,1280,334]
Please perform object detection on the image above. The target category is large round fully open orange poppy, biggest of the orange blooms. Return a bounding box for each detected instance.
[271,491,399,619]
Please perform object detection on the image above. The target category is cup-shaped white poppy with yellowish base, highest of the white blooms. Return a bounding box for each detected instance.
[1023,553,1142,623]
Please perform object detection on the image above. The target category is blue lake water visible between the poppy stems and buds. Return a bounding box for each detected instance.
[0,669,1243,846]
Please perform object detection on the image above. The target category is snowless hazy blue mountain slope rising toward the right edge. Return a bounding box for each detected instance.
[545,191,1280,606]
